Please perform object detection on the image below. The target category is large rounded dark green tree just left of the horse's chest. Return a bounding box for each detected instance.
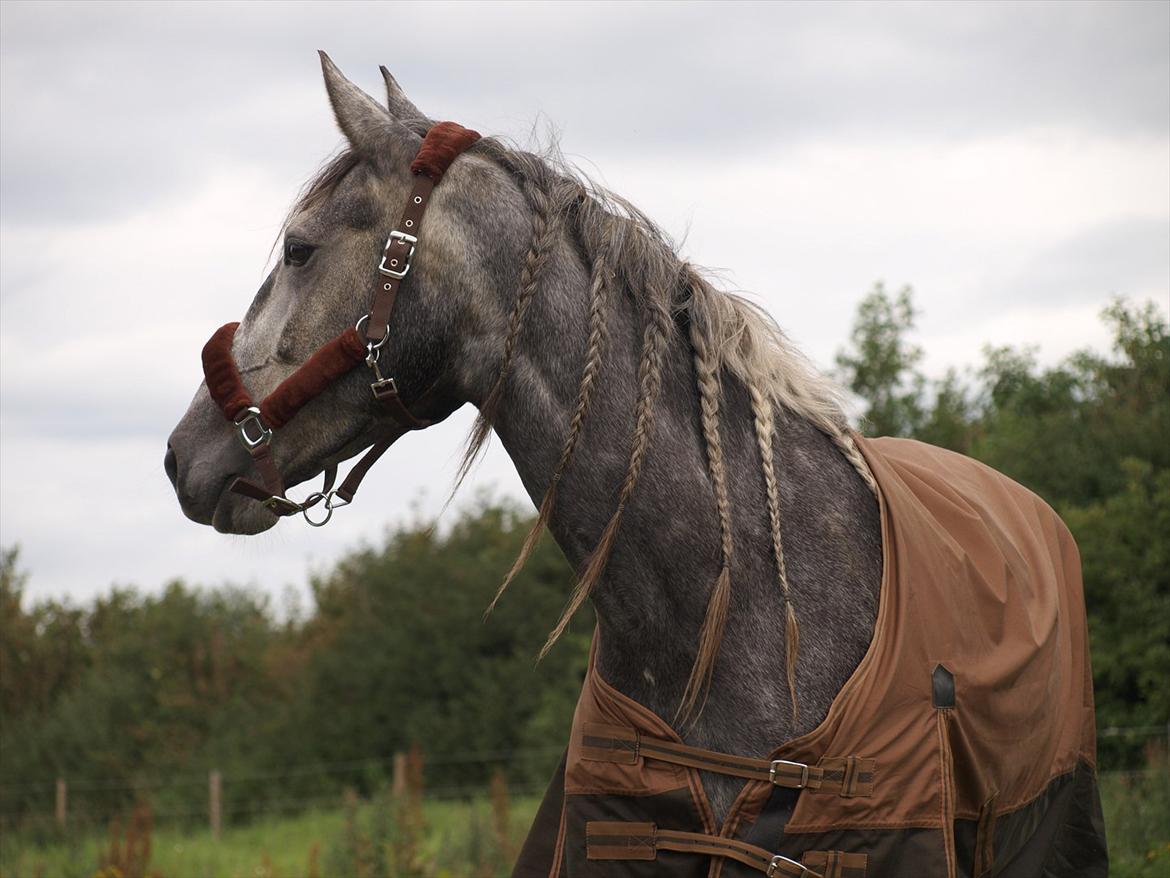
[292,503,592,786]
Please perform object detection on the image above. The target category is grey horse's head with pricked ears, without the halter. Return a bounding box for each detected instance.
[165,53,532,534]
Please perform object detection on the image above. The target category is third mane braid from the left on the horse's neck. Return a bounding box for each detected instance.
[541,295,674,658]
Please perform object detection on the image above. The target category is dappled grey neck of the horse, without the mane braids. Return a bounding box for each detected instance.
[477,235,881,810]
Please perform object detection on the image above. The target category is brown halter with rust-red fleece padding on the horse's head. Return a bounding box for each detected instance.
[202,122,480,527]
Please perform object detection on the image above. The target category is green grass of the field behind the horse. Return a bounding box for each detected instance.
[0,763,1170,878]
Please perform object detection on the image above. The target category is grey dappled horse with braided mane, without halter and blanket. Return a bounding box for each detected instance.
[166,56,882,816]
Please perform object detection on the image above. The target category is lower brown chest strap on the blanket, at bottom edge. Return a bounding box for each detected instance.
[585,821,851,878]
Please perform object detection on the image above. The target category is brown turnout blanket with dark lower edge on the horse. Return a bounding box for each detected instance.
[515,438,1108,878]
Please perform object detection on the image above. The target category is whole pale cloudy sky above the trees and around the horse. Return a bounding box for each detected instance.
[0,0,1170,603]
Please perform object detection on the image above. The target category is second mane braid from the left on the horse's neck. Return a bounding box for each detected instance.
[484,234,613,616]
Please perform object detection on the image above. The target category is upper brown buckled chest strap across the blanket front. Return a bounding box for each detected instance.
[580,722,876,797]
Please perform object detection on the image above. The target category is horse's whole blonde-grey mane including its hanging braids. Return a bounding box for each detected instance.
[456,138,876,722]
